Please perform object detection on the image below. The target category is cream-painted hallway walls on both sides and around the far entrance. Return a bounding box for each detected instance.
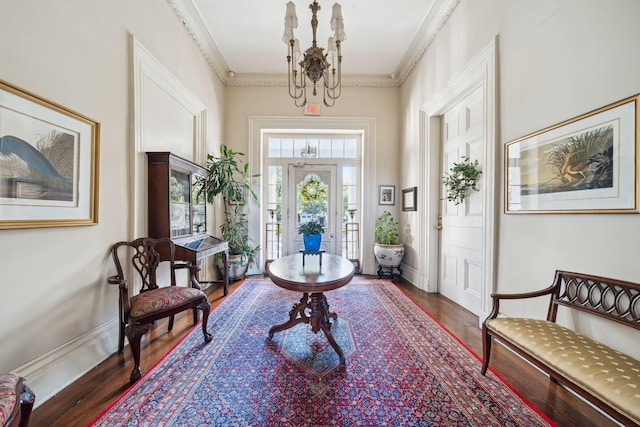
[0,0,640,404]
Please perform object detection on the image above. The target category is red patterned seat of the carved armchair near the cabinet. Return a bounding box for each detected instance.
[129,286,205,319]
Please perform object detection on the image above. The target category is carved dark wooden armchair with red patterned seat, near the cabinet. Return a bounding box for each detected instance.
[108,237,213,383]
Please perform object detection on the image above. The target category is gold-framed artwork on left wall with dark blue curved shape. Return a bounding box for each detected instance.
[0,81,100,229]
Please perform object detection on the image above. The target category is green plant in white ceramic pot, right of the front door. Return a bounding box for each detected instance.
[373,211,405,277]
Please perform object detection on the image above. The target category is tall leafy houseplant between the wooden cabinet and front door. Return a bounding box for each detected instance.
[206,144,260,279]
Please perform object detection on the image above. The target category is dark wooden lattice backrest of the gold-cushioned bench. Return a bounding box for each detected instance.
[547,270,640,329]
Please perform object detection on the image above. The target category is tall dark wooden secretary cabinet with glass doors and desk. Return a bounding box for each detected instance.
[147,151,229,295]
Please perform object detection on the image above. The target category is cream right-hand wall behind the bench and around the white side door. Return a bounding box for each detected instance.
[401,0,640,357]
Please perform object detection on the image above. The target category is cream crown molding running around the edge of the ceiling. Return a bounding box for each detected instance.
[167,0,461,88]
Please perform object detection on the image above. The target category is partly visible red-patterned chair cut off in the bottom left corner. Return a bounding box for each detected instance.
[0,374,36,427]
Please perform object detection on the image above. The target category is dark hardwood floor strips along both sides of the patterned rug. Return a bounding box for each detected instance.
[30,280,617,427]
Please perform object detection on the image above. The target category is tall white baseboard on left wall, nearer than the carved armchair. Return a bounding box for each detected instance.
[14,319,118,408]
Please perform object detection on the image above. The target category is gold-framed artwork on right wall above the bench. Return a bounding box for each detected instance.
[505,95,640,213]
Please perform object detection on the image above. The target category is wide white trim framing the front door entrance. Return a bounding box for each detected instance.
[248,116,377,274]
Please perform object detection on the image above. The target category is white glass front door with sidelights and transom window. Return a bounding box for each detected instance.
[261,131,362,270]
